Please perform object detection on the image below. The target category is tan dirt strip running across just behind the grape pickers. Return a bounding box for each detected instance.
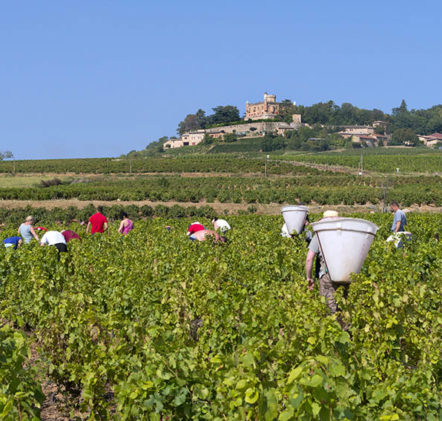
[0,199,442,215]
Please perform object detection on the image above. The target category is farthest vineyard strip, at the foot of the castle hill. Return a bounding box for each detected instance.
[0,148,442,175]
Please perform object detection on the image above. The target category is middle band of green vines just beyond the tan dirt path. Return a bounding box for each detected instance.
[0,174,442,206]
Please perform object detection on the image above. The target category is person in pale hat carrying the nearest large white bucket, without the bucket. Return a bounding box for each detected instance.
[305,210,348,314]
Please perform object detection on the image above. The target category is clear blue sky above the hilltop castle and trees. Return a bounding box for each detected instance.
[0,0,442,159]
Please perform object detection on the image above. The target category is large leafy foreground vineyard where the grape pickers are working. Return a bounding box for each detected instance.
[0,214,442,421]
